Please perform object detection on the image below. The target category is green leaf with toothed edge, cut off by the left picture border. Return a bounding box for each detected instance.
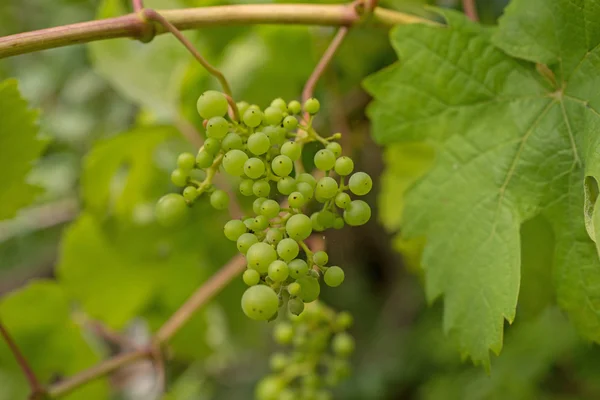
[0,80,46,220]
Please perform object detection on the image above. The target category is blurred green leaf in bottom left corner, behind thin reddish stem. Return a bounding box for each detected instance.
[0,281,109,400]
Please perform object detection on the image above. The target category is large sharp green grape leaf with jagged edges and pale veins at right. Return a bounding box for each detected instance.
[365,0,600,366]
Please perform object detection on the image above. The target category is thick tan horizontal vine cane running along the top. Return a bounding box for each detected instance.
[0,4,435,58]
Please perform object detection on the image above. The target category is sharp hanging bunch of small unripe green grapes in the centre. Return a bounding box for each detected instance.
[156,91,373,320]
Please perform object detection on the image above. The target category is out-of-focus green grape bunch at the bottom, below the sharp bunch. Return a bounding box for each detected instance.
[255,301,355,400]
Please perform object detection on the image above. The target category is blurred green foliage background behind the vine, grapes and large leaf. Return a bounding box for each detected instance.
[0,0,600,400]
